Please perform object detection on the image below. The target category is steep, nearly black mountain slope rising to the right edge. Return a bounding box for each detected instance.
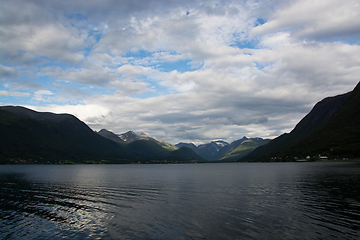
[240,83,360,161]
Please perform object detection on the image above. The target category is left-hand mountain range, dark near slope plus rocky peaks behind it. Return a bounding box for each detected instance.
[0,106,204,164]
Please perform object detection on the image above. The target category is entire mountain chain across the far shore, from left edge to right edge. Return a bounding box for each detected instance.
[0,83,360,164]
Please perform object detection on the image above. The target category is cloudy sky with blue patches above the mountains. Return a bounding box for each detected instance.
[0,0,360,144]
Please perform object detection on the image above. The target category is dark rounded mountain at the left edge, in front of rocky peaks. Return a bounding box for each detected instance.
[0,106,129,163]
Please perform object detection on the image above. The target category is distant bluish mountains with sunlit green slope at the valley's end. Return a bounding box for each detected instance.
[175,137,270,161]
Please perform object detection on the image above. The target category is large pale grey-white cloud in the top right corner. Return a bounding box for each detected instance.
[251,0,360,41]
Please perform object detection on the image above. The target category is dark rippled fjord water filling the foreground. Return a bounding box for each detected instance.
[0,163,360,239]
